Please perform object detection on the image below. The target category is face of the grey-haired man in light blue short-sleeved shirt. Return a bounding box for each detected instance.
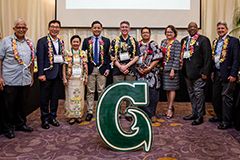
[13,21,28,39]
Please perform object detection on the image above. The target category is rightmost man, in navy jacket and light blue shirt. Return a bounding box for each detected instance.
[209,22,240,129]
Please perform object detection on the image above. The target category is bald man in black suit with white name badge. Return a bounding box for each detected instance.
[181,22,212,125]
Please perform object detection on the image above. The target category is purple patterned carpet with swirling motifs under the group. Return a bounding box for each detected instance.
[0,103,240,160]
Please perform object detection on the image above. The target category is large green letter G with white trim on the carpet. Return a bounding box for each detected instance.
[96,81,152,152]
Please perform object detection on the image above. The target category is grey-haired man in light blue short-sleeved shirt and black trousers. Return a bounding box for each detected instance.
[0,18,35,138]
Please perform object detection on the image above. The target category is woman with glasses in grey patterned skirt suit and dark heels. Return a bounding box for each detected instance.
[161,25,181,118]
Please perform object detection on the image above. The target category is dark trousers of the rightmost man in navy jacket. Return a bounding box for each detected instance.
[212,72,236,124]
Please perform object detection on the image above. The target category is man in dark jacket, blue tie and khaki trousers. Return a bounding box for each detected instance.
[82,21,110,121]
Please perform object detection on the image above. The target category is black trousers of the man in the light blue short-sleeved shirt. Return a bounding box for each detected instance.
[2,85,30,132]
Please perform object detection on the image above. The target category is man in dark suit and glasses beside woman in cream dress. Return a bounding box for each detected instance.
[37,20,64,129]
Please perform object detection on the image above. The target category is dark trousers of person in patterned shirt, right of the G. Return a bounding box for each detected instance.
[139,87,159,118]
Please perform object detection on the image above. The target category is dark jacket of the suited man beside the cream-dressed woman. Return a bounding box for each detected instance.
[37,36,62,79]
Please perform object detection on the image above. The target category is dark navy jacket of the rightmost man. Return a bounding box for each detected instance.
[213,35,240,81]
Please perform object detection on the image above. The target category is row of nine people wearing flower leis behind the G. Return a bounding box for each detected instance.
[0,18,240,138]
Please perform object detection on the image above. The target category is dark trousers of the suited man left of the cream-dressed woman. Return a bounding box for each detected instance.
[40,77,62,122]
